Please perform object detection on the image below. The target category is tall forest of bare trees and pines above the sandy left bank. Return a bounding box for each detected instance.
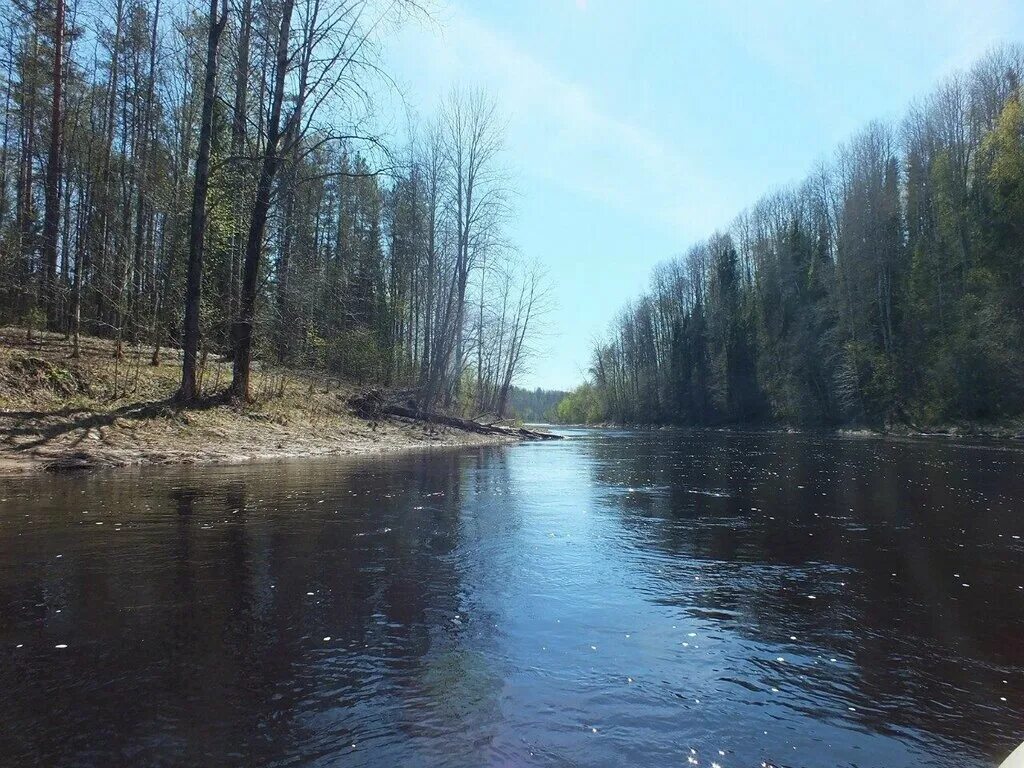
[0,0,547,415]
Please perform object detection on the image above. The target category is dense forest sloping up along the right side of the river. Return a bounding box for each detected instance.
[558,47,1024,425]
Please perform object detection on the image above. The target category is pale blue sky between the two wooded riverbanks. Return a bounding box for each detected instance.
[383,0,1024,389]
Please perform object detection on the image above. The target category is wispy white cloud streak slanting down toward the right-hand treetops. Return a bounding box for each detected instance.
[389,3,722,237]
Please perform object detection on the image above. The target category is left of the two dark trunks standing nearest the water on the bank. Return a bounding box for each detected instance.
[178,0,227,402]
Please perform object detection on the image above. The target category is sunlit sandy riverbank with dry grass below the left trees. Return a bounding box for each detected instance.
[0,329,515,474]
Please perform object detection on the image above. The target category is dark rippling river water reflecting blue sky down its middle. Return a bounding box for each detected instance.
[0,431,1024,768]
